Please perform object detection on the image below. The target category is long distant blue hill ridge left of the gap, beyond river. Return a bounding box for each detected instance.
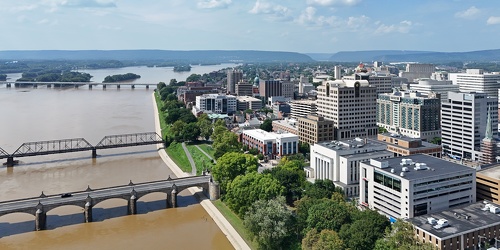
[0,50,314,63]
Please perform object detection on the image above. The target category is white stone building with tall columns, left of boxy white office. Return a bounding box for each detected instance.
[310,138,394,197]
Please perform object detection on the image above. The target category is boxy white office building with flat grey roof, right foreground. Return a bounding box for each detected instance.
[359,154,476,220]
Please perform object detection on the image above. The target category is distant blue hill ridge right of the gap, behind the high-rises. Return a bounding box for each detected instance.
[329,49,500,63]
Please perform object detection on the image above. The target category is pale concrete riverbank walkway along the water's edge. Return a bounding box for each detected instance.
[152,93,250,250]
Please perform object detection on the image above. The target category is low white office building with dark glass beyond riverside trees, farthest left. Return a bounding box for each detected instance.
[195,94,236,114]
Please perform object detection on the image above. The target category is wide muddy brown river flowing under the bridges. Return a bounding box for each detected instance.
[0,65,233,250]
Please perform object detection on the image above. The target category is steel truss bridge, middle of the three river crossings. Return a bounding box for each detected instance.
[0,132,164,167]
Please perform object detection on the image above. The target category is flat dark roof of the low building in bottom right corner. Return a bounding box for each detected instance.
[409,202,500,239]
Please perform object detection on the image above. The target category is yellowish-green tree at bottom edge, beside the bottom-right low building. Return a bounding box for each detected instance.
[374,219,435,250]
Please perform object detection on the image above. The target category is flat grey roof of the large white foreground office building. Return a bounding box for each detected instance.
[365,154,474,180]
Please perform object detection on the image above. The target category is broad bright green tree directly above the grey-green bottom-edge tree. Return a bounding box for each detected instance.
[224,173,285,217]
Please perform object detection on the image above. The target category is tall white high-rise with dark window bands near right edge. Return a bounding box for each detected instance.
[441,92,498,161]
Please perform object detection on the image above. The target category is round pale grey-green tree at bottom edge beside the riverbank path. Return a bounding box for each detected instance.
[243,196,294,249]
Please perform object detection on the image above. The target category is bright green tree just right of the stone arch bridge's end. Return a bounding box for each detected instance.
[212,152,259,193]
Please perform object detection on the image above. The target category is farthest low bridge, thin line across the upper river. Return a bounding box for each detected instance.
[0,81,156,89]
